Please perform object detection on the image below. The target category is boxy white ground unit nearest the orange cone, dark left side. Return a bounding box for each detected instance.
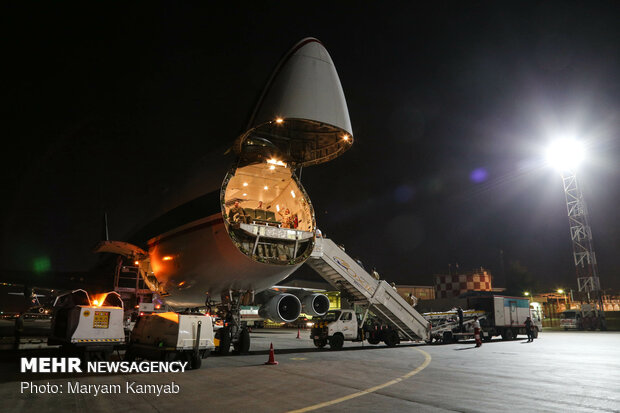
[125,312,215,369]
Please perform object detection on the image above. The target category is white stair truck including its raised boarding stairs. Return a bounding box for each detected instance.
[307,238,430,350]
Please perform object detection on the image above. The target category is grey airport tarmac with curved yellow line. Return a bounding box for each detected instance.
[0,329,620,413]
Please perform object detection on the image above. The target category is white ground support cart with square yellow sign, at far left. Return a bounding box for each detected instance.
[48,290,125,361]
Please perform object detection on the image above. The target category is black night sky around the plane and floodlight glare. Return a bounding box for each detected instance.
[0,1,620,289]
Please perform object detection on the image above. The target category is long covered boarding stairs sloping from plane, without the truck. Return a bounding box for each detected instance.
[306,238,430,341]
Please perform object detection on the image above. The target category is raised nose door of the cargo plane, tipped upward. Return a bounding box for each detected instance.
[233,38,353,165]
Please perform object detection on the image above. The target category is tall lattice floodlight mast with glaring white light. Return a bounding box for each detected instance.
[547,139,602,300]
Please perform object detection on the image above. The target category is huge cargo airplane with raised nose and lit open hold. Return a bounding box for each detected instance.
[96,38,353,353]
